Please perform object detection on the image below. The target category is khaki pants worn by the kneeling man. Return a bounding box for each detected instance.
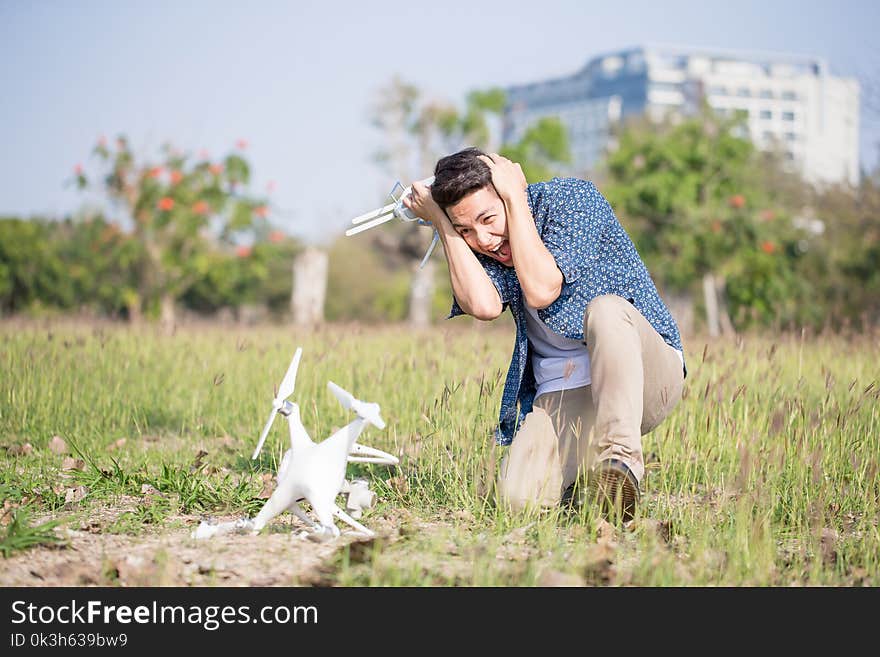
[498,294,684,509]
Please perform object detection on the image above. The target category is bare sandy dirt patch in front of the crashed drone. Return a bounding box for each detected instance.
[0,509,406,586]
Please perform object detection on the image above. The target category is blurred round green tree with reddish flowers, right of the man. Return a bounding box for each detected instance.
[605,106,800,335]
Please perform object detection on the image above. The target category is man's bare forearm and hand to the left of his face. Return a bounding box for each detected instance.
[403,182,504,320]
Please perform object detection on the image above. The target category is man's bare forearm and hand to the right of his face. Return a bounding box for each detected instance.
[480,153,563,308]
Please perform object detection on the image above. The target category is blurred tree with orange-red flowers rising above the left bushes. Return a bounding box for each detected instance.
[77,136,267,328]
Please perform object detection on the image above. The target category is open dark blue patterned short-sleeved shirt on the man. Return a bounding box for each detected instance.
[449,178,682,445]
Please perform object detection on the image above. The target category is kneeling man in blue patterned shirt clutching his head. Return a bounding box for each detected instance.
[405,148,686,521]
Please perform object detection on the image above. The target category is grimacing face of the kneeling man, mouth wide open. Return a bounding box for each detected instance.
[446,185,513,267]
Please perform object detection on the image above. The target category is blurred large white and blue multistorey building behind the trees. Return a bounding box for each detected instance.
[502,45,860,185]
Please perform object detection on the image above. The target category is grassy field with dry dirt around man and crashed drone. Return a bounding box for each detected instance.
[0,320,880,586]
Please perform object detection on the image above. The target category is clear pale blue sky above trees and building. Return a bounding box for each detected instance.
[0,0,880,244]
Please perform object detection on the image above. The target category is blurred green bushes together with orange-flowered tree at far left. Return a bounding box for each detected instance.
[0,137,301,319]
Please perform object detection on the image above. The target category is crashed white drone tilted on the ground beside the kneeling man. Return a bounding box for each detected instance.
[193,348,399,538]
